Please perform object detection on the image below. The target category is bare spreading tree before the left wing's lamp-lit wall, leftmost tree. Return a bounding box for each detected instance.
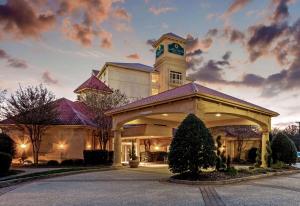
[4,84,58,164]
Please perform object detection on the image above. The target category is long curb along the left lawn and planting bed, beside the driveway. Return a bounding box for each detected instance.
[0,167,117,188]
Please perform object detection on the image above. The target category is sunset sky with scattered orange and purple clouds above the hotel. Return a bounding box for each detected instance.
[0,0,300,127]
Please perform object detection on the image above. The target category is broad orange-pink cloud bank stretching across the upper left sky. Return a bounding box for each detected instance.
[0,0,127,48]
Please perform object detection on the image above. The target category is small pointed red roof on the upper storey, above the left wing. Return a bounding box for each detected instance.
[74,75,112,93]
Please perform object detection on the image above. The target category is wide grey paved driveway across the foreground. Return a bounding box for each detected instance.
[0,168,300,206]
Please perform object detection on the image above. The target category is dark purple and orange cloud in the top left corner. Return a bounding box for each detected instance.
[0,0,56,38]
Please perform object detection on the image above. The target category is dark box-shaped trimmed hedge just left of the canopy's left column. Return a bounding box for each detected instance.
[83,150,113,165]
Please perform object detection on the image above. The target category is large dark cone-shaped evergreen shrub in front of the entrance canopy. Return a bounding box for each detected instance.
[169,114,216,174]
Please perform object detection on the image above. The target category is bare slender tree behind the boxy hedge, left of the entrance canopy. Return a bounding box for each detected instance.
[83,90,129,150]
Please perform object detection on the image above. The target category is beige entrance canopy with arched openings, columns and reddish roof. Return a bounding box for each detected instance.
[107,83,279,167]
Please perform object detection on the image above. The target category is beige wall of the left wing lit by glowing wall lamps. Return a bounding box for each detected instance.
[7,126,94,161]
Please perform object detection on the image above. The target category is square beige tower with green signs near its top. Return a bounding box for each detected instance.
[152,33,187,94]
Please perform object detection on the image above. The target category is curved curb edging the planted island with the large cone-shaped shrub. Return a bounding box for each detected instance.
[167,170,300,185]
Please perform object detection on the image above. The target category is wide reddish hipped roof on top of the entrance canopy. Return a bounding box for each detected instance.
[107,82,278,116]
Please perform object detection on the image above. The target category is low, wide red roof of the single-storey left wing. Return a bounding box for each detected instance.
[0,98,96,127]
